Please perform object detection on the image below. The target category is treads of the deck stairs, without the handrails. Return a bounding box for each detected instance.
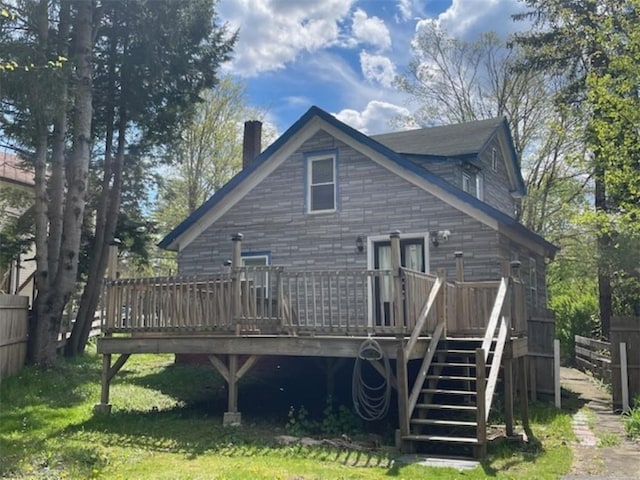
[403,338,496,457]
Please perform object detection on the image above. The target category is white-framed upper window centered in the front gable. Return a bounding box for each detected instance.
[307,155,336,213]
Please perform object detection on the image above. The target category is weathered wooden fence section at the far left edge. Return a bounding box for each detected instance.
[0,295,29,379]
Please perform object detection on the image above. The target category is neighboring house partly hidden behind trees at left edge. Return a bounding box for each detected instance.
[0,152,35,298]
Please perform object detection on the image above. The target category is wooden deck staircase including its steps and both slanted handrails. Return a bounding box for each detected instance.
[398,277,511,458]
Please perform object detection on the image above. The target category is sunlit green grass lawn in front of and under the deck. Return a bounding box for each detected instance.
[0,346,573,480]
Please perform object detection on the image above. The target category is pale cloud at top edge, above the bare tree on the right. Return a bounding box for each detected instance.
[424,0,529,40]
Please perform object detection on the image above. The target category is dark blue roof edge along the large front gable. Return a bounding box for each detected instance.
[158,106,558,256]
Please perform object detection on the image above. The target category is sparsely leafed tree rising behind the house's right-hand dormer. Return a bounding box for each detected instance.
[397,23,585,242]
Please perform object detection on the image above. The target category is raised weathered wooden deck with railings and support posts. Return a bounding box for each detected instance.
[96,236,527,456]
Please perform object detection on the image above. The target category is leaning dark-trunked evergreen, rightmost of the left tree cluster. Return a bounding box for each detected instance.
[65,0,235,355]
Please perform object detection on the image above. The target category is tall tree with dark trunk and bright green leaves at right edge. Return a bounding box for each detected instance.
[515,0,639,337]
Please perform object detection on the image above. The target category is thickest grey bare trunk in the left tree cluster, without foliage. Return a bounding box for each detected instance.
[34,0,94,365]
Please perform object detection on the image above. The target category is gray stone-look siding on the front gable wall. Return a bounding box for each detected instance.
[179,132,500,280]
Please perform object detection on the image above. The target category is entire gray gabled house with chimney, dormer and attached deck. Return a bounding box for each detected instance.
[97,107,556,456]
